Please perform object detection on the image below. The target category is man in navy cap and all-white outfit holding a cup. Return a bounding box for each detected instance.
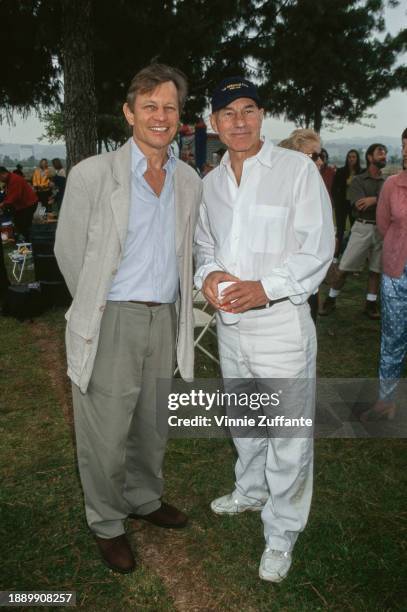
[195,77,334,582]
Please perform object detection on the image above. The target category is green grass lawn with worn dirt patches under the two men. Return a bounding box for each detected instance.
[0,251,407,612]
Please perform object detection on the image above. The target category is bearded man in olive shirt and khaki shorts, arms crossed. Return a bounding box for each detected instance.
[319,142,387,320]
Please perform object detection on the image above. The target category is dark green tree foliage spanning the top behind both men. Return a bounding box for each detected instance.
[0,0,407,136]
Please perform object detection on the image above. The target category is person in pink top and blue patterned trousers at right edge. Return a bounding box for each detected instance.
[361,128,407,421]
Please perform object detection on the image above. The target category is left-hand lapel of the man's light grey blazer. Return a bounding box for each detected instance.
[110,142,131,250]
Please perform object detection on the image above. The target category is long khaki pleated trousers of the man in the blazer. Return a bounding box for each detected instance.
[72,302,176,538]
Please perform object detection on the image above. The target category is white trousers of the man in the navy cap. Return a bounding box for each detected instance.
[217,301,317,551]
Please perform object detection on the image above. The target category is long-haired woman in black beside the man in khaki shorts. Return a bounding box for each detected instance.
[332,149,362,263]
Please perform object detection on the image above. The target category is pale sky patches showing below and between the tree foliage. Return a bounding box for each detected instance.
[0,0,407,144]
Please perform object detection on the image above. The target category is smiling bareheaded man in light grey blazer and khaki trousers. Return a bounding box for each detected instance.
[55,64,201,573]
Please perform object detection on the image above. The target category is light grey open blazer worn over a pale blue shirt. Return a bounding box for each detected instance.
[55,142,202,393]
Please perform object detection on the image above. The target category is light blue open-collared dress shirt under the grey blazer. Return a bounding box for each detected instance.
[107,138,179,303]
